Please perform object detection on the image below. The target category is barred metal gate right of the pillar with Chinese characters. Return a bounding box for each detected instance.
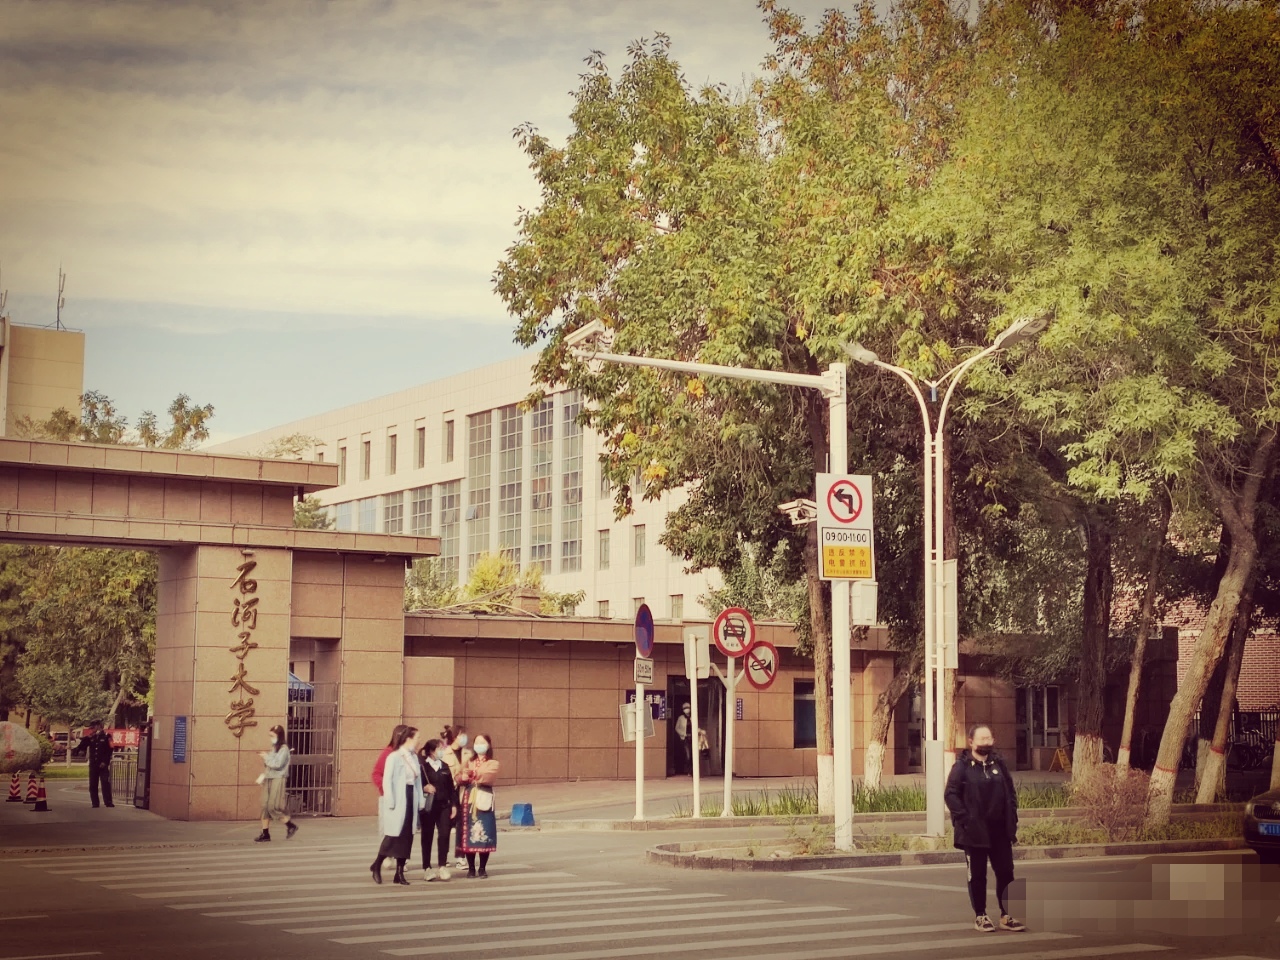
[285,673,338,817]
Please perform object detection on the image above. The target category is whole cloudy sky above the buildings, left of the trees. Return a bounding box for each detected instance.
[0,0,833,442]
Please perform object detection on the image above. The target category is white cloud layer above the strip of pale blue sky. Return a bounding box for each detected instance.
[0,0,834,325]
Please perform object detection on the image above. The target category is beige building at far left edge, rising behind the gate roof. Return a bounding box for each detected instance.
[0,317,84,436]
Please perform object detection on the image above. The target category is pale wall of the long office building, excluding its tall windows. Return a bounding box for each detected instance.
[210,355,721,621]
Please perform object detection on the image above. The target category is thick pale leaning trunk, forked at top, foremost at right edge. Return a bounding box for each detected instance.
[1146,428,1276,827]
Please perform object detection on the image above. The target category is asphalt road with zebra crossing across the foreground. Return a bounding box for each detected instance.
[0,829,1280,960]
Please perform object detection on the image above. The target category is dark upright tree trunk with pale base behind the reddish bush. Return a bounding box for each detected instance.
[1071,506,1115,782]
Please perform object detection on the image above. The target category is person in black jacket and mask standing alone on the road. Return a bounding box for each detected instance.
[945,723,1027,933]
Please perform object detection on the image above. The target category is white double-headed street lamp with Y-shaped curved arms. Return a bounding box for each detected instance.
[845,317,1048,837]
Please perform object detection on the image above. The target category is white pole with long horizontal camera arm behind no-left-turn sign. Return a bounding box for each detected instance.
[566,320,854,850]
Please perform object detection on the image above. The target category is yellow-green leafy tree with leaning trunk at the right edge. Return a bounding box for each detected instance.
[927,0,1280,823]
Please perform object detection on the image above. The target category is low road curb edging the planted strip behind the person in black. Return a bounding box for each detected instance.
[645,837,1248,873]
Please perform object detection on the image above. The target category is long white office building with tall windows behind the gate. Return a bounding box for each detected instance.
[211,353,719,620]
